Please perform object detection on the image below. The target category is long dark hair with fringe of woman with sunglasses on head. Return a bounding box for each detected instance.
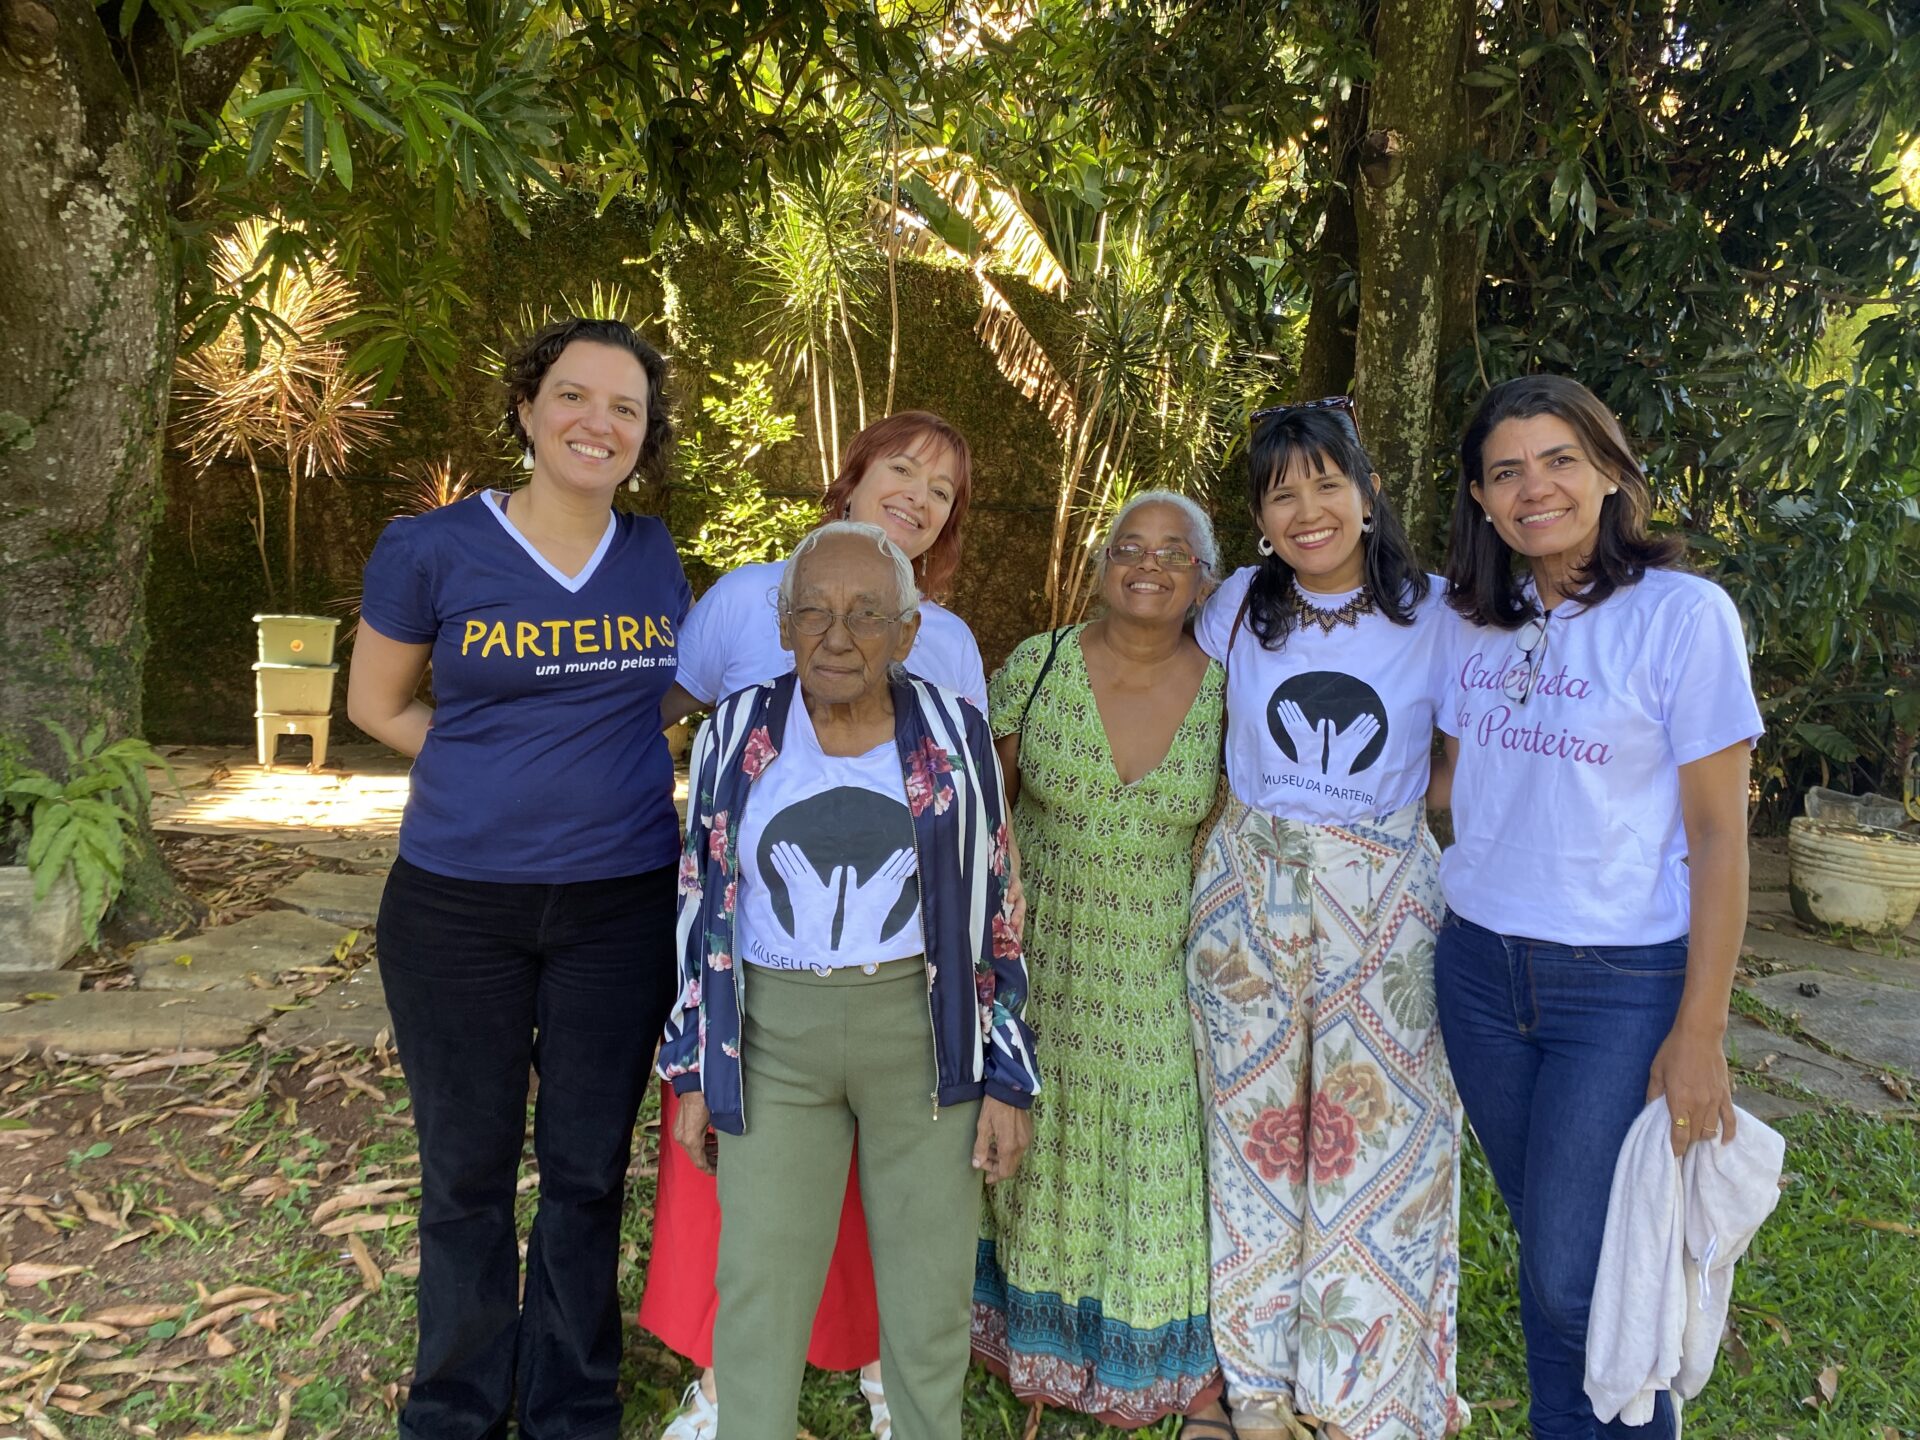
[1246,407,1432,651]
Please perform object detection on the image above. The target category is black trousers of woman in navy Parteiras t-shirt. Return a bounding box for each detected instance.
[378,860,674,1440]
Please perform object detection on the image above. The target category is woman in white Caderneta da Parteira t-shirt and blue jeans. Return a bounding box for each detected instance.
[1434,374,1761,1440]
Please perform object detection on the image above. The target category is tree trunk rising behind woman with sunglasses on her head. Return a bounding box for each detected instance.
[1354,0,1475,540]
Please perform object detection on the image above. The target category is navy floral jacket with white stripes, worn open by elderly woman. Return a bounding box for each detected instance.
[660,674,1041,1135]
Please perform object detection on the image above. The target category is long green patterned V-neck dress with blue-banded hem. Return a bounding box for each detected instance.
[973,626,1225,1427]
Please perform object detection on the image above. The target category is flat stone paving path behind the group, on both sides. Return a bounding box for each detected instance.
[0,760,1920,1119]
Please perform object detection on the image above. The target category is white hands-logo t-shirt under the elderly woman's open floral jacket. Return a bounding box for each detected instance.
[735,695,925,973]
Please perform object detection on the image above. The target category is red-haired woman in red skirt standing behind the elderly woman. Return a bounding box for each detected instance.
[639,411,987,1440]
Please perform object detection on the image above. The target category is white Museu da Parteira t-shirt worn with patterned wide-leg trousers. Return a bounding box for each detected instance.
[1194,566,1457,826]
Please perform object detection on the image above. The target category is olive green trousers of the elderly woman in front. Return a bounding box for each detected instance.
[714,956,981,1440]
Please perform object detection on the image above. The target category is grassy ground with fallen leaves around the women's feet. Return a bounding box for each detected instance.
[0,1052,1920,1440]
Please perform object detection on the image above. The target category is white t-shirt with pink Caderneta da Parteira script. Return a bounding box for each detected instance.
[1440,570,1763,945]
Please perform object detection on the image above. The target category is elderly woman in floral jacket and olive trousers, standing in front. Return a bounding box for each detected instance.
[660,520,1039,1440]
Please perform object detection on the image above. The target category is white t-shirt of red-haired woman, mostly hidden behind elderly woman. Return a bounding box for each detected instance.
[676,561,987,714]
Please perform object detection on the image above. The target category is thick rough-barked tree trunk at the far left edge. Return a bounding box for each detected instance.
[0,0,175,779]
